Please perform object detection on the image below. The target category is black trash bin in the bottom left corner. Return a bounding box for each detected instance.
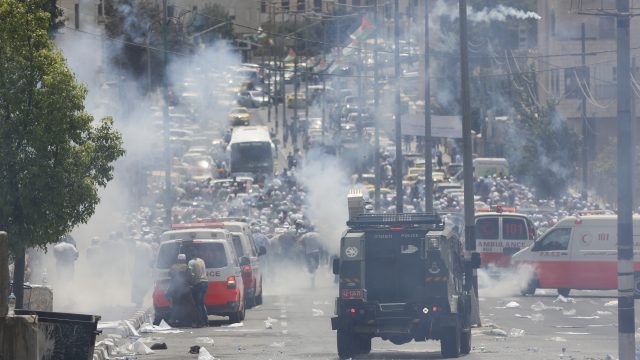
[15,309,101,360]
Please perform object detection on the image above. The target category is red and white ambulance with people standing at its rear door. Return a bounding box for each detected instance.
[153,228,245,324]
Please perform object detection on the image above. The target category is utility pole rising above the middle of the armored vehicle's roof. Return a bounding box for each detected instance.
[393,0,404,214]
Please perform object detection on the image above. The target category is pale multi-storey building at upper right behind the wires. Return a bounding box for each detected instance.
[534,0,640,152]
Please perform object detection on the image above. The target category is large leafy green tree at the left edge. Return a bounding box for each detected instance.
[0,0,124,305]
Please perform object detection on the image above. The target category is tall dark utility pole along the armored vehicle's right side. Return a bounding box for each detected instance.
[459,0,480,325]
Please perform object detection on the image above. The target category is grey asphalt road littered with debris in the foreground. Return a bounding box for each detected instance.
[136,268,638,359]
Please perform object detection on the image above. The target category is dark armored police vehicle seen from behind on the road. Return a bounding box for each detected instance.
[331,193,477,359]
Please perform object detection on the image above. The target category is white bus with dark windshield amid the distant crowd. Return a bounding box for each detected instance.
[227,126,276,176]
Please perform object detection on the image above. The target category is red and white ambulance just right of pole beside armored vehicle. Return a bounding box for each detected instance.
[476,205,536,268]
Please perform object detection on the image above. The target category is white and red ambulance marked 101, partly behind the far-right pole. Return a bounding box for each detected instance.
[512,215,640,296]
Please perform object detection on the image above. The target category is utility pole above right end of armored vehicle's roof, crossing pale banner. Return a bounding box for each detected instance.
[423,0,433,211]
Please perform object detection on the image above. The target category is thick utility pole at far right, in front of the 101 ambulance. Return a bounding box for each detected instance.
[616,0,636,360]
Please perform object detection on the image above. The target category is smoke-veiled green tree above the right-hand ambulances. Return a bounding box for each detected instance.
[507,68,580,196]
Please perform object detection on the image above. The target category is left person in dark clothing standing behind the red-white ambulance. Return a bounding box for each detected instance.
[167,254,197,327]
